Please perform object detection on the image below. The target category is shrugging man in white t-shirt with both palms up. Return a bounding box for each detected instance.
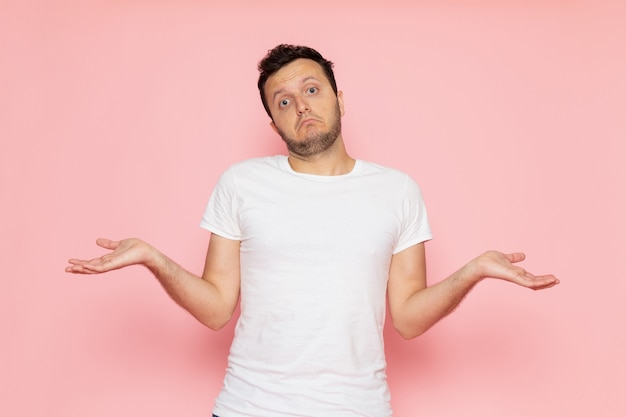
[67,45,558,417]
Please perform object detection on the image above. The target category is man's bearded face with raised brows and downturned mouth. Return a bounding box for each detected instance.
[265,59,344,158]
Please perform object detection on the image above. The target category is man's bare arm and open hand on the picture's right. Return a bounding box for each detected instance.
[387,243,559,339]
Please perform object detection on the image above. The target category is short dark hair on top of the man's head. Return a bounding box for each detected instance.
[258,44,337,119]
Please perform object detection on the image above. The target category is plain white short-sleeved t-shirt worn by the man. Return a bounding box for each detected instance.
[201,156,431,417]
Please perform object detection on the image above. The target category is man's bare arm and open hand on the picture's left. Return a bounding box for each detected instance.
[65,234,240,330]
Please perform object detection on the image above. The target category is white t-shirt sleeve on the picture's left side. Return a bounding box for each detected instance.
[200,167,241,240]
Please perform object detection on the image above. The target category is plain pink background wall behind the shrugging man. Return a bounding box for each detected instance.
[0,0,626,417]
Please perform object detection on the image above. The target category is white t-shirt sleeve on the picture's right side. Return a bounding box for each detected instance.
[393,176,433,254]
